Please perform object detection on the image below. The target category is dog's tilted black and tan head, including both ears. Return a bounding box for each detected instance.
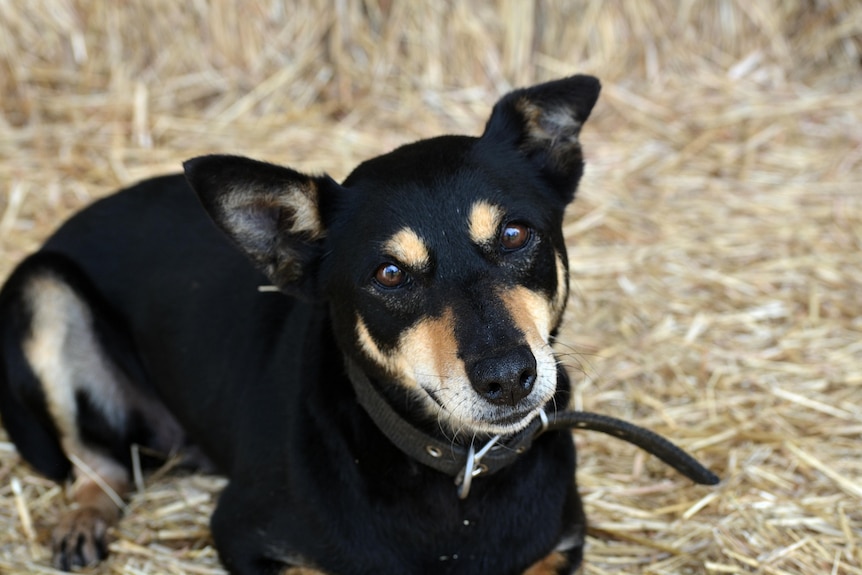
[185,76,599,434]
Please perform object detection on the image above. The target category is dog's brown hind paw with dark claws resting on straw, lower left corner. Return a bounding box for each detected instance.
[51,507,113,571]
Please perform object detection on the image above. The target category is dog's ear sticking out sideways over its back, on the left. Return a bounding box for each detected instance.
[183,156,338,292]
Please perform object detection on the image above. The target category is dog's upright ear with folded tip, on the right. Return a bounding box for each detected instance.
[482,75,601,202]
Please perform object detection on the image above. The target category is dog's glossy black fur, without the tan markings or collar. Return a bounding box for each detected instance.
[0,76,599,575]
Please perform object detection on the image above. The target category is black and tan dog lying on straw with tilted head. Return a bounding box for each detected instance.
[0,76,640,575]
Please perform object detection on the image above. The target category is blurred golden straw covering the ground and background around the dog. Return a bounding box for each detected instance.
[0,0,862,575]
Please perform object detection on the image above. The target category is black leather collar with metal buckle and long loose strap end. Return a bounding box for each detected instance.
[347,360,719,498]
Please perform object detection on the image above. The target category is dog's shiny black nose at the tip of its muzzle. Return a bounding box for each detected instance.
[468,347,536,406]
